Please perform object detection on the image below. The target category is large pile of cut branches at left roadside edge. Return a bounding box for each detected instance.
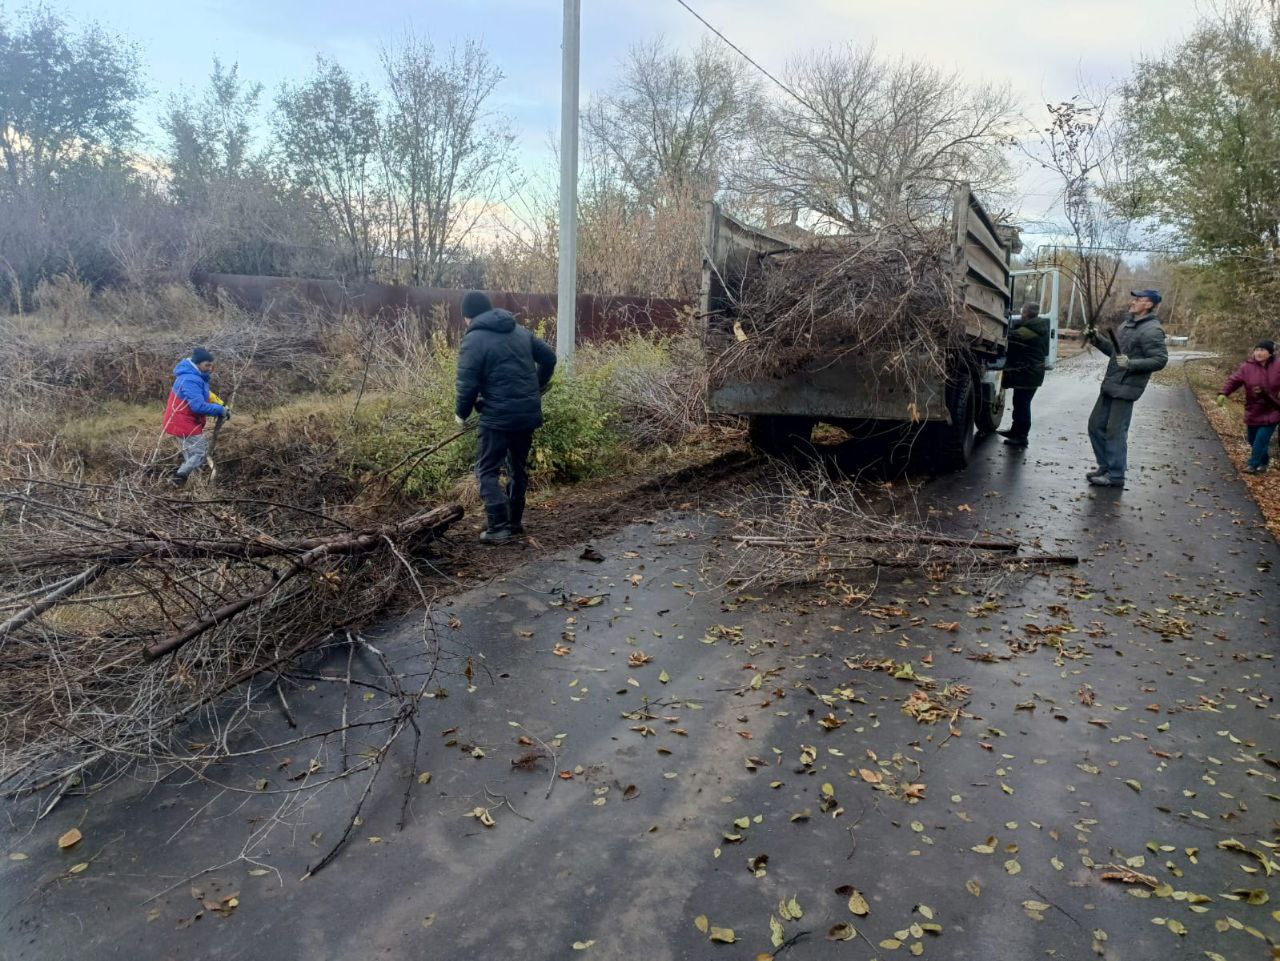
[0,477,462,804]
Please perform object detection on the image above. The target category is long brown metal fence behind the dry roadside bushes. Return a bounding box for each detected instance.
[192,273,692,342]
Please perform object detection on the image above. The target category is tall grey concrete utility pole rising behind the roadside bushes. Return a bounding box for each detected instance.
[556,0,582,361]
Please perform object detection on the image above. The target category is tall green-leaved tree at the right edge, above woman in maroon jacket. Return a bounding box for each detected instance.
[1125,0,1280,347]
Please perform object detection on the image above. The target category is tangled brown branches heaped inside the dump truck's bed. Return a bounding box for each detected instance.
[712,230,964,386]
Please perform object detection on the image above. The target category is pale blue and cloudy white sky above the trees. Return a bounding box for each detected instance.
[54,0,1197,227]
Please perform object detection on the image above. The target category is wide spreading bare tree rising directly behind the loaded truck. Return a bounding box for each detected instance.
[749,46,1014,230]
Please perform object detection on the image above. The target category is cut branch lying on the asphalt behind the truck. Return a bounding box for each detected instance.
[730,471,1078,590]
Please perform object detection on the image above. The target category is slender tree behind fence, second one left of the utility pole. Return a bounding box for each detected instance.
[275,58,385,279]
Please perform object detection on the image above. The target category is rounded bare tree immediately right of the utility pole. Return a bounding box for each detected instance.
[582,40,759,205]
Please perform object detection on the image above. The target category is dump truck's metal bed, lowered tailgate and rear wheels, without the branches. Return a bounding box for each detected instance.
[701,187,1020,471]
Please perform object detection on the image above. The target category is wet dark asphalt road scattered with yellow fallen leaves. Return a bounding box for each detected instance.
[0,358,1280,961]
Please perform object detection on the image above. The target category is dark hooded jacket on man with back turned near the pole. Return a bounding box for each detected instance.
[454,310,556,430]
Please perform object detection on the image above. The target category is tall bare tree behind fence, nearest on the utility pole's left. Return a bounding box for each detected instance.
[381,33,515,284]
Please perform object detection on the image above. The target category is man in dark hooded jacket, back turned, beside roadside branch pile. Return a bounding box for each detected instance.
[454,290,556,544]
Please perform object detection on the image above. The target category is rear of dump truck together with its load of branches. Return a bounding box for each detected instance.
[701,187,1010,467]
